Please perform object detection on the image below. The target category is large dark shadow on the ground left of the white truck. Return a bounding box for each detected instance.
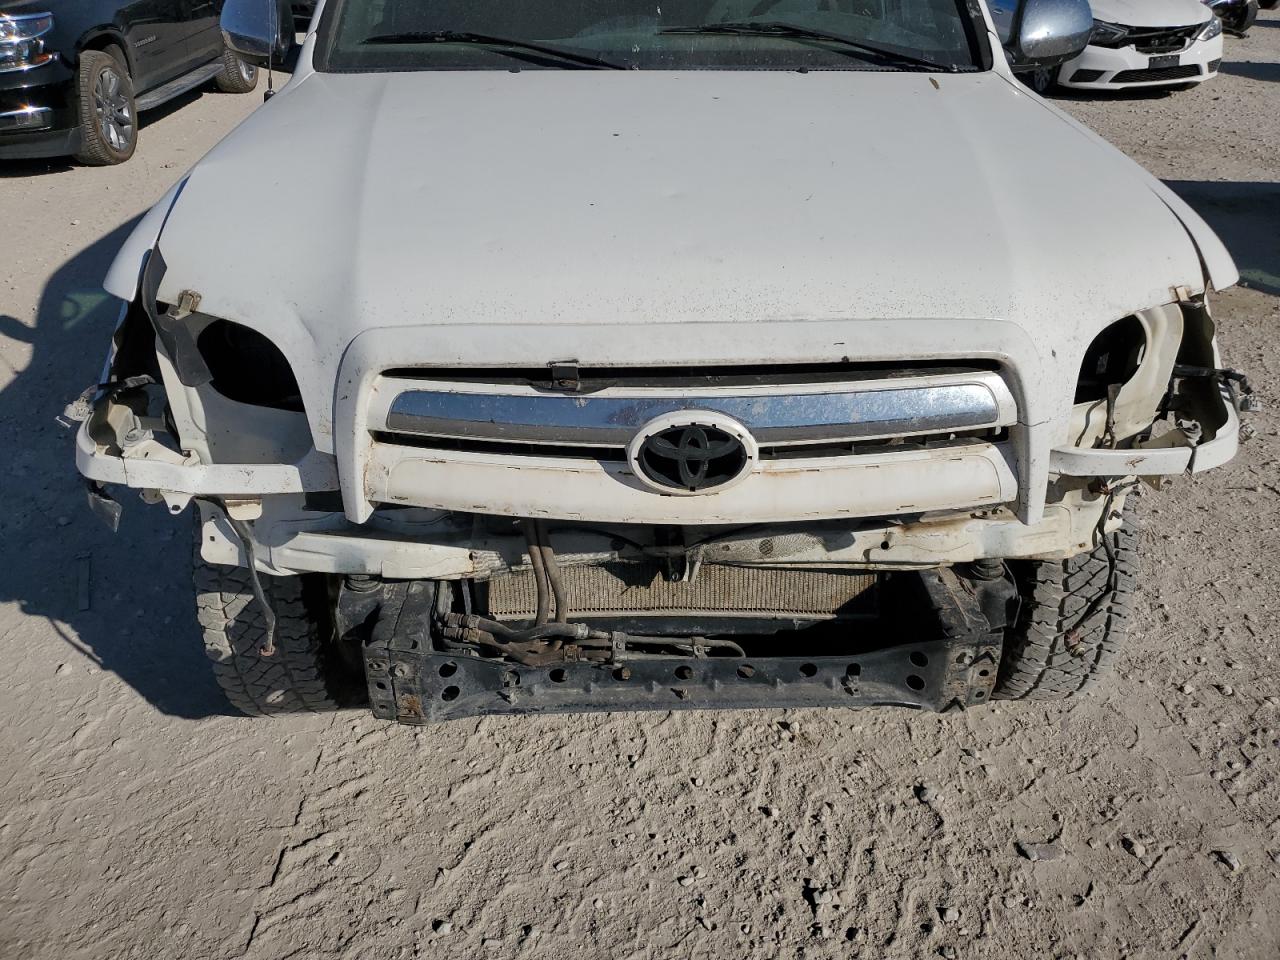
[0,213,229,718]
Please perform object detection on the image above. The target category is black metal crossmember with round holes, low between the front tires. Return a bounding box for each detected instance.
[364,570,1004,724]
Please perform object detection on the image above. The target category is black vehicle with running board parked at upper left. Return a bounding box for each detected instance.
[0,0,257,165]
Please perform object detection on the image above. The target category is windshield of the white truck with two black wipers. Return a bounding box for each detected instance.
[316,0,983,72]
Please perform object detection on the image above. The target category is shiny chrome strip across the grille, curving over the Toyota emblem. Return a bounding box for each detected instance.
[387,381,1011,447]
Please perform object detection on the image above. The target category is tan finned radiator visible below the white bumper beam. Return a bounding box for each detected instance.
[488,561,877,620]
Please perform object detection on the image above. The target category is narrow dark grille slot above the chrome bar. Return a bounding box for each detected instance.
[383,360,1000,393]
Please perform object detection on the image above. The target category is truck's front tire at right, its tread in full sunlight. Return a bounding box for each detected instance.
[995,507,1138,700]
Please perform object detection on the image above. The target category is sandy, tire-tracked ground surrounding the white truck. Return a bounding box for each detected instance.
[0,13,1280,960]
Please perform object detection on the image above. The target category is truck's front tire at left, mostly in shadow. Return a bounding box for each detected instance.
[195,547,364,717]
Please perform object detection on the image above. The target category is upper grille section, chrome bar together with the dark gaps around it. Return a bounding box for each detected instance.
[370,362,1016,460]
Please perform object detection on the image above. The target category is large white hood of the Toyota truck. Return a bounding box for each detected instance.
[140,70,1204,449]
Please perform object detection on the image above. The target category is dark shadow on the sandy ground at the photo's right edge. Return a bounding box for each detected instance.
[1166,180,1280,297]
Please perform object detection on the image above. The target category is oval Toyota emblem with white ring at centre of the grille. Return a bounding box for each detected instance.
[627,411,756,494]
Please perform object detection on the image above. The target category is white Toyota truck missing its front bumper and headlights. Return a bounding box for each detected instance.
[77,0,1248,723]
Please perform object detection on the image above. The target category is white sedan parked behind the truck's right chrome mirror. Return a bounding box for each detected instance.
[995,0,1222,93]
